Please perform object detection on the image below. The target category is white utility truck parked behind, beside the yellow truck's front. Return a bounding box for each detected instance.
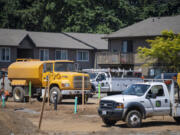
[83,69,143,95]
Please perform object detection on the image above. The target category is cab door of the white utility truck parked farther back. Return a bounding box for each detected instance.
[96,73,110,92]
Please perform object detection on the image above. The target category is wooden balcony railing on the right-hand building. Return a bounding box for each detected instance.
[96,52,134,64]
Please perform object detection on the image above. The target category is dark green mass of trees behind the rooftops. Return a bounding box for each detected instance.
[0,0,180,33]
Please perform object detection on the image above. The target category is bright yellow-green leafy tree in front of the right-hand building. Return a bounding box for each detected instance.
[138,30,180,72]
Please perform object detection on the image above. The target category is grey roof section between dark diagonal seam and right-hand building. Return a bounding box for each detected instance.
[64,33,108,50]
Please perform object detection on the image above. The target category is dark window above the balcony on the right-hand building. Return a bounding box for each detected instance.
[121,40,133,53]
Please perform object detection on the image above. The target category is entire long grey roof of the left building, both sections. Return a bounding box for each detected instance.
[0,29,108,50]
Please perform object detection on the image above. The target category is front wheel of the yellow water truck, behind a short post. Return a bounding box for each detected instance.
[50,87,62,104]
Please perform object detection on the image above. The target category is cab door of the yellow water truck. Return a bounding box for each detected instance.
[42,63,53,87]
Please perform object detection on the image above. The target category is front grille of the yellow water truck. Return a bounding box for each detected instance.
[73,76,90,89]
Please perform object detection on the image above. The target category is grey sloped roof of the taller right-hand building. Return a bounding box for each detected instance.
[104,15,180,38]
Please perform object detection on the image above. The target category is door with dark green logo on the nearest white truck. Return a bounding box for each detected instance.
[147,85,170,115]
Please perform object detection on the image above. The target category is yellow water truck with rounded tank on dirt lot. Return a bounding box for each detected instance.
[8,60,91,103]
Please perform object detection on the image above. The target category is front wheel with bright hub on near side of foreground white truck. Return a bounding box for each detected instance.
[126,110,142,128]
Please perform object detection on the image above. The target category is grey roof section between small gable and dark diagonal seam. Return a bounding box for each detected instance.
[28,32,93,49]
